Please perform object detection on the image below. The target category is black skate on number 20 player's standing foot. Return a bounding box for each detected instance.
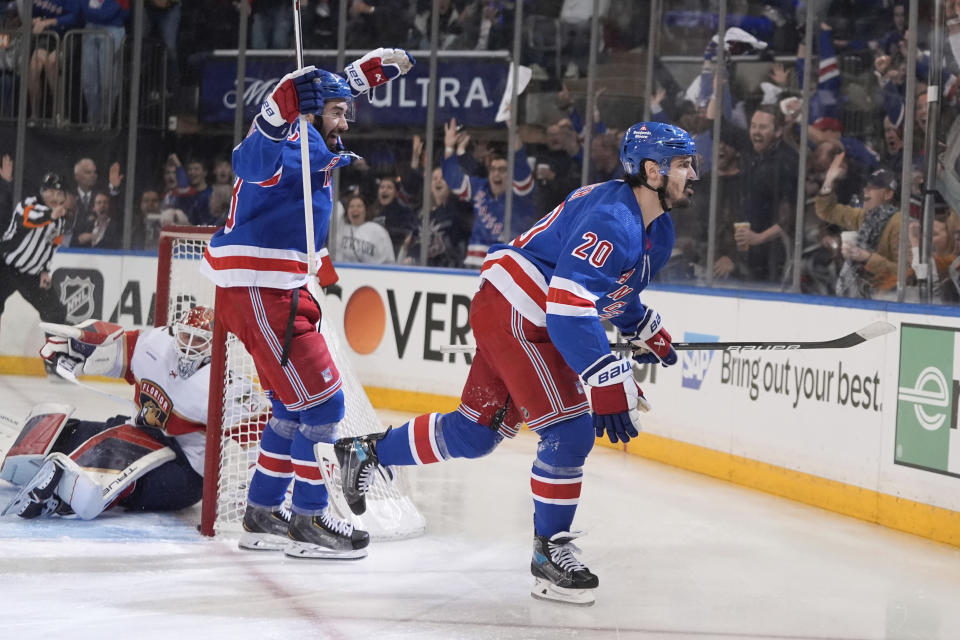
[530,531,600,605]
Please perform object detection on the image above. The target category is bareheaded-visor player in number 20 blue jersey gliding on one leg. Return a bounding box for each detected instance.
[334,122,697,604]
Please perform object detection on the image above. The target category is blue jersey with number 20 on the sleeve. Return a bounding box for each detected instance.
[480,180,675,373]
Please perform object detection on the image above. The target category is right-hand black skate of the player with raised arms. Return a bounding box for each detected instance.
[284,509,370,560]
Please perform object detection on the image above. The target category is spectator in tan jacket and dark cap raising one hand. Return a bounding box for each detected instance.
[814,153,900,298]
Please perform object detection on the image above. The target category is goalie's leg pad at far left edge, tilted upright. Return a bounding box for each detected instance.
[0,402,74,486]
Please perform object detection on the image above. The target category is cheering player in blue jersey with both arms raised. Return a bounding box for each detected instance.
[201,48,414,559]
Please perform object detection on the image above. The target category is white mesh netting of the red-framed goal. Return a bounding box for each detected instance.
[157,230,425,539]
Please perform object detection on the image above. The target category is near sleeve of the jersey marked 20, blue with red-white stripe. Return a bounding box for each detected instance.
[547,203,644,373]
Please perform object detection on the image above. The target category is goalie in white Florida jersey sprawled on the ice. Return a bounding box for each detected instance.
[0,307,213,520]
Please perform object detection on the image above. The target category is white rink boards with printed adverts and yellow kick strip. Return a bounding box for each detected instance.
[0,251,960,546]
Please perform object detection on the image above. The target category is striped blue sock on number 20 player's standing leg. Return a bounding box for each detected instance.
[530,414,595,538]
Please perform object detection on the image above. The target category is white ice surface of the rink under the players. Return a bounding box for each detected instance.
[0,376,960,640]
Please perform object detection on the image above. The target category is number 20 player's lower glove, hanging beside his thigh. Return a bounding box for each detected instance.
[580,354,650,442]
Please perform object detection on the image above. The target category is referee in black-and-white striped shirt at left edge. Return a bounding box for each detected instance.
[0,173,67,332]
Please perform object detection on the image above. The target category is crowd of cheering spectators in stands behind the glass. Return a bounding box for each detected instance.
[1,0,960,301]
